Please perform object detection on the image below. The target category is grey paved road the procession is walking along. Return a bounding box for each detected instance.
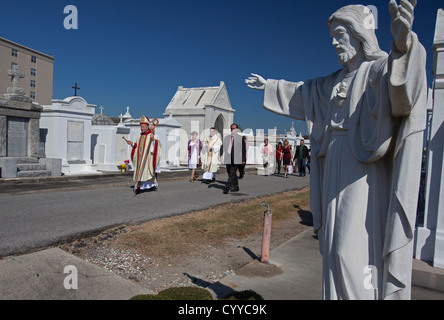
[0,173,309,257]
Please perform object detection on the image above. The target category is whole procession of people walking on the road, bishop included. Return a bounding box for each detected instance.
[127,116,310,194]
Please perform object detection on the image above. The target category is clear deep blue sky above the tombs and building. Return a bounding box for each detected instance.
[0,0,443,133]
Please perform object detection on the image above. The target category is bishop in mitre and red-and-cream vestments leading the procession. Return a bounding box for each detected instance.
[127,116,162,194]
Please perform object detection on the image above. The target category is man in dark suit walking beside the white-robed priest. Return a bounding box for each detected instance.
[221,123,247,194]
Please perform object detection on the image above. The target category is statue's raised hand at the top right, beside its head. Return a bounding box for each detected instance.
[389,0,417,53]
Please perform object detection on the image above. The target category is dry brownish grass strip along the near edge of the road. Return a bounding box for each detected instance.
[118,188,310,256]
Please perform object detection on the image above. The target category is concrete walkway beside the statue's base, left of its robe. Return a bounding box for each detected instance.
[210,229,322,300]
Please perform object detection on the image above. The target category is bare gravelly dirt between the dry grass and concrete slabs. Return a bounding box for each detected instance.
[59,190,311,292]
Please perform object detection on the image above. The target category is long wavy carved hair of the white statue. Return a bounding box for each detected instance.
[328,5,387,61]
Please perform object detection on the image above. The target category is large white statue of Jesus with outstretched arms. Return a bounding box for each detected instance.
[246,0,427,299]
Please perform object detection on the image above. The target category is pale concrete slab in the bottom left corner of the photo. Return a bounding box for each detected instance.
[0,248,152,300]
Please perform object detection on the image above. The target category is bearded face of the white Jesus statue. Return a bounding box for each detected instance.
[330,21,361,66]
